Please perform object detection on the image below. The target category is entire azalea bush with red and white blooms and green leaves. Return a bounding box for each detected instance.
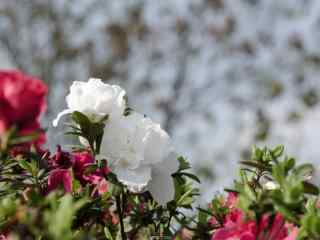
[0,71,320,240]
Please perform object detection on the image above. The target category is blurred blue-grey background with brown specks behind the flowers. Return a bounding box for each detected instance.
[0,0,320,200]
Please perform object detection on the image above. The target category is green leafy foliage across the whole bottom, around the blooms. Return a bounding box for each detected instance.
[0,113,320,240]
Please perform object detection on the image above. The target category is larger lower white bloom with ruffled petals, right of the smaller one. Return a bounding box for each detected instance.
[101,112,178,204]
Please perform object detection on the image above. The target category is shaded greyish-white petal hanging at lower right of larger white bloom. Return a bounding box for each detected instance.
[147,152,179,205]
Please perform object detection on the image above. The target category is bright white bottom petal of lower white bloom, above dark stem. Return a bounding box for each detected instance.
[113,166,151,192]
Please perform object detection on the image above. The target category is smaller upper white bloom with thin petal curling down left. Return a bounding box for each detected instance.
[53,78,126,126]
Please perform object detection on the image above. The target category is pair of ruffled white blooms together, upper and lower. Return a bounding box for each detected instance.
[55,79,178,204]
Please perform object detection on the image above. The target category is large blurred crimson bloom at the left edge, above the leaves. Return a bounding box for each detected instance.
[0,71,48,144]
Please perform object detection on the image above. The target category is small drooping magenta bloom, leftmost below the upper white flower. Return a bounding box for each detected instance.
[47,169,72,193]
